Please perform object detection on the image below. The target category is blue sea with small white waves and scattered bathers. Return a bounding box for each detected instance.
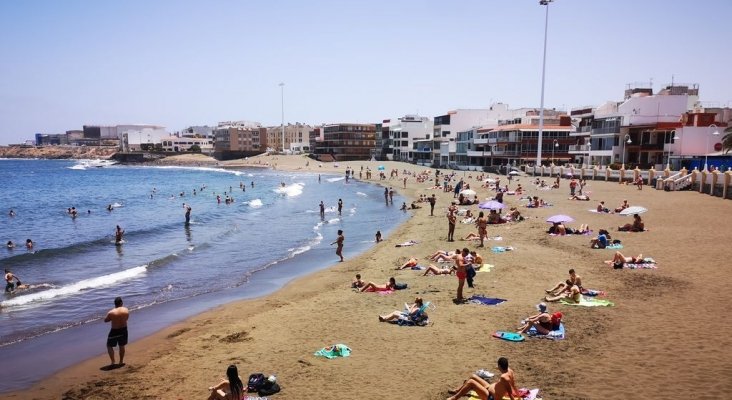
[0,159,408,392]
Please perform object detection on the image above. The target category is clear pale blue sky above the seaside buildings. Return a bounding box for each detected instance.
[0,0,732,144]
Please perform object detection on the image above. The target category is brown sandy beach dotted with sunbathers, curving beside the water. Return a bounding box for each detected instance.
[0,156,732,400]
